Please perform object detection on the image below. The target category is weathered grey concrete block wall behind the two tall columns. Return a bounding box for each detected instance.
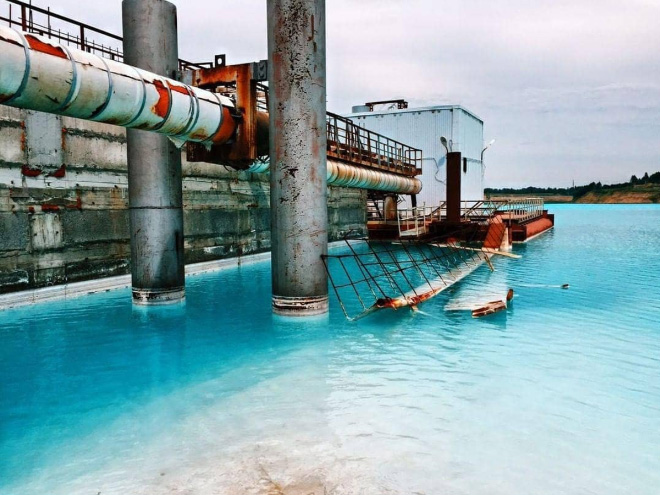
[0,105,366,293]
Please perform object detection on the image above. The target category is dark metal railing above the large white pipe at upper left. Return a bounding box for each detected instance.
[0,0,213,70]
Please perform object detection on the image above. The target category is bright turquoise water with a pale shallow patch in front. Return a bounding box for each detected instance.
[0,205,660,495]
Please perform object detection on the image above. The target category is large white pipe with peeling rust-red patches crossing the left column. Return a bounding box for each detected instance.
[0,26,236,146]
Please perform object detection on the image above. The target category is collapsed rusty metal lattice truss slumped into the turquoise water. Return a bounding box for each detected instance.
[322,202,518,321]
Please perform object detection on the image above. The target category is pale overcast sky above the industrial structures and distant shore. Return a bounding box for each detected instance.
[16,0,660,187]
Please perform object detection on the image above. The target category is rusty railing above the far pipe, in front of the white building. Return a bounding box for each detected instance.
[327,112,422,177]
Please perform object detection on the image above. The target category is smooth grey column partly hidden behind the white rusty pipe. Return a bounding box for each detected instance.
[122,0,185,304]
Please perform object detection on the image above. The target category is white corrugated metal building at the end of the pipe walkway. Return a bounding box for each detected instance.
[346,105,484,208]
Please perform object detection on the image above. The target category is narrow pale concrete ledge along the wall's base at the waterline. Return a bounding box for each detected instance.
[0,241,356,311]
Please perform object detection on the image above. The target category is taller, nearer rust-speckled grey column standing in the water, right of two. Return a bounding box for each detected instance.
[268,0,328,315]
